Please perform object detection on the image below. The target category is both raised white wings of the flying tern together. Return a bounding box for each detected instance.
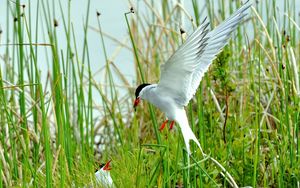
[158,1,251,106]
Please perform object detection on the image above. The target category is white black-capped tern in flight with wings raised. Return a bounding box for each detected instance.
[134,1,251,155]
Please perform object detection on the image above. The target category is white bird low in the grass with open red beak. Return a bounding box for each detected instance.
[95,160,114,187]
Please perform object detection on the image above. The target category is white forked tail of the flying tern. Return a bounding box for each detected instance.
[177,109,205,155]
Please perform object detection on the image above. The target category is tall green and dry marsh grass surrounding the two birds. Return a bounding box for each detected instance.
[0,0,300,187]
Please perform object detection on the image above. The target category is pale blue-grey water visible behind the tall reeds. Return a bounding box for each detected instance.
[0,0,300,94]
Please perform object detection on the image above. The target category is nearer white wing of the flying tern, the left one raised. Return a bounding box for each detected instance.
[157,18,209,105]
